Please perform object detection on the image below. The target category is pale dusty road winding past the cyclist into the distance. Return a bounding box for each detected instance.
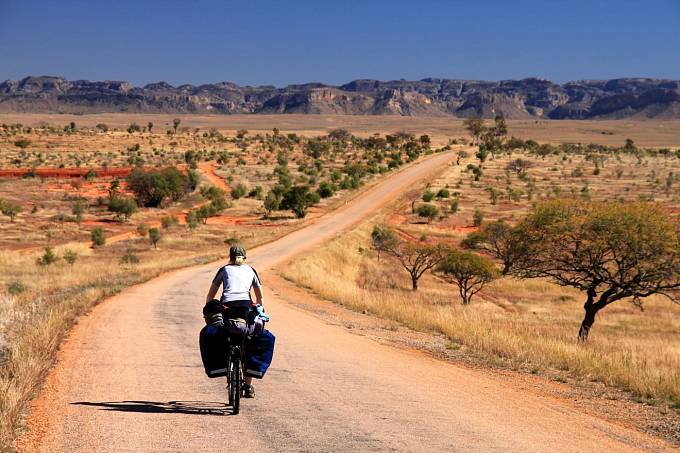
[17,155,670,452]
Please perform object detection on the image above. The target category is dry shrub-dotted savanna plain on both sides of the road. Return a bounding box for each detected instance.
[0,114,680,446]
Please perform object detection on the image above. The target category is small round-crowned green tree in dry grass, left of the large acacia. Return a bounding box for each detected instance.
[436,250,498,305]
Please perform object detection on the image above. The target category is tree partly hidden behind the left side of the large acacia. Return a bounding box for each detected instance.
[462,220,526,275]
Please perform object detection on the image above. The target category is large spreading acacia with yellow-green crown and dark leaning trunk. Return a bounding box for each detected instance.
[513,200,680,341]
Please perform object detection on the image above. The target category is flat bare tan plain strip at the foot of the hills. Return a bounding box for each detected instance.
[0,113,680,147]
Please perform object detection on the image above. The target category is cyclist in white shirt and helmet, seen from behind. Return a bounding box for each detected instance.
[205,245,263,398]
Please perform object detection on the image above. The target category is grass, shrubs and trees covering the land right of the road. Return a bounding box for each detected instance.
[284,118,680,409]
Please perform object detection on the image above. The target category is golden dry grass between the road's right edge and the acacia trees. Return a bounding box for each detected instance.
[284,224,680,406]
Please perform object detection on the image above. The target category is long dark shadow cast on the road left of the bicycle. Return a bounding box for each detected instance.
[71,401,231,415]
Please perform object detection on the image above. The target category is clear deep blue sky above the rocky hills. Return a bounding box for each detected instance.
[0,0,680,86]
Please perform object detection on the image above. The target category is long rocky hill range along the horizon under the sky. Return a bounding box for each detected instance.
[0,76,680,119]
